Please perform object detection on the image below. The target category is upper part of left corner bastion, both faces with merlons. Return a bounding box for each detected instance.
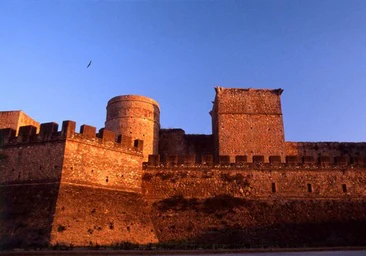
[0,121,143,192]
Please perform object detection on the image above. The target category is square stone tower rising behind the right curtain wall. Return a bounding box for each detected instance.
[210,87,285,162]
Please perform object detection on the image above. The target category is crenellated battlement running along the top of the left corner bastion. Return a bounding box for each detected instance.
[0,120,144,153]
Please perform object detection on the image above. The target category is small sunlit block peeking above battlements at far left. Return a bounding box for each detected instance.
[0,110,40,135]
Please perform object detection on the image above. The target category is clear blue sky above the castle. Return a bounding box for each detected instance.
[0,0,366,141]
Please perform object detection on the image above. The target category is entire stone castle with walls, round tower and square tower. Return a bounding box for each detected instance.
[0,87,366,248]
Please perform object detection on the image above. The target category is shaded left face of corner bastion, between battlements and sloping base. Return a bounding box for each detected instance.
[0,141,65,183]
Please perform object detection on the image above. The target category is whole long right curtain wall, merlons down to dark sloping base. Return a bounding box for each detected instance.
[142,155,366,248]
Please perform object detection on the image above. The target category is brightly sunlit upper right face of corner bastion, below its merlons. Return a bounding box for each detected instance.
[62,135,142,192]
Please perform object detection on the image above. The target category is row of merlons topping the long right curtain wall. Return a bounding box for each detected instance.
[143,155,366,169]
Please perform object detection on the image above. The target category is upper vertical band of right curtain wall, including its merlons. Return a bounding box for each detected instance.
[143,153,366,199]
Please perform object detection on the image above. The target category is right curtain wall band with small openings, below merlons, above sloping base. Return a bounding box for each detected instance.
[142,165,366,200]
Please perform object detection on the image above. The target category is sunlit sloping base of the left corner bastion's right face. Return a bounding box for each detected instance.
[50,184,157,246]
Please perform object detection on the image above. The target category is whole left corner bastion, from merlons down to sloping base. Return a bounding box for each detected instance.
[0,121,157,249]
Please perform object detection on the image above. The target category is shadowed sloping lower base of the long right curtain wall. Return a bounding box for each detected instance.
[149,195,366,248]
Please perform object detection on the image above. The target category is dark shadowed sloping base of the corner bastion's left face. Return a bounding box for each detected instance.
[0,183,59,250]
